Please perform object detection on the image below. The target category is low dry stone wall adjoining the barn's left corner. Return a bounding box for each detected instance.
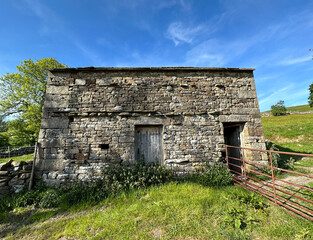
[0,160,33,197]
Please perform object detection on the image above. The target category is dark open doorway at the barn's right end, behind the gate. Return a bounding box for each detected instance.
[223,123,244,174]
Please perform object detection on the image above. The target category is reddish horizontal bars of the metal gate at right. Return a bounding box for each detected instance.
[226,145,313,221]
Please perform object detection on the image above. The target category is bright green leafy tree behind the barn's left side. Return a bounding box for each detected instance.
[0,58,67,144]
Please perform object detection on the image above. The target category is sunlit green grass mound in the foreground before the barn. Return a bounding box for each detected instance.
[0,183,313,240]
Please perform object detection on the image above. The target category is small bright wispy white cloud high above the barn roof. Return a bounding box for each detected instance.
[166,22,203,46]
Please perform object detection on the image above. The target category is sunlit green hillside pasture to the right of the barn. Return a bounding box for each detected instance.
[262,113,313,153]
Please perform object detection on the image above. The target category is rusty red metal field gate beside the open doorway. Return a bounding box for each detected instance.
[226,145,313,221]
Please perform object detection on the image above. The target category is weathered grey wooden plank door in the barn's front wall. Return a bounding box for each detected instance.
[135,126,163,164]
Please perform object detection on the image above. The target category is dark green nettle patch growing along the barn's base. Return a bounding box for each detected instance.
[0,162,232,212]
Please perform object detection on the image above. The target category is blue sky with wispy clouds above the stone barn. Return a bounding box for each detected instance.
[0,0,313,111]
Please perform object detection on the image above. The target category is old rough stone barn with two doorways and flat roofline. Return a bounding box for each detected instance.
[36,67,265,184]
